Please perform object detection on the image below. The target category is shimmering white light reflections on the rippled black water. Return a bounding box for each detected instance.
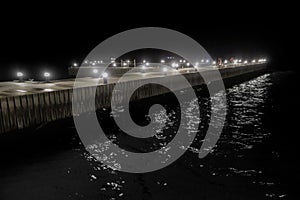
[83,74,286,199]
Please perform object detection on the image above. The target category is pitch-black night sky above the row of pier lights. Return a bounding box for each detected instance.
[0,3,298,80]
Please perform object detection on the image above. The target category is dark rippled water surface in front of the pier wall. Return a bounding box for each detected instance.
[0,72,299,200]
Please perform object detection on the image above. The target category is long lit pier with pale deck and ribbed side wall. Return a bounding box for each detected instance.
[0,63,267,134]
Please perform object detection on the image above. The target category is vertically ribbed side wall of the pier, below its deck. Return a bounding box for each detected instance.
[0,64,266,134]
